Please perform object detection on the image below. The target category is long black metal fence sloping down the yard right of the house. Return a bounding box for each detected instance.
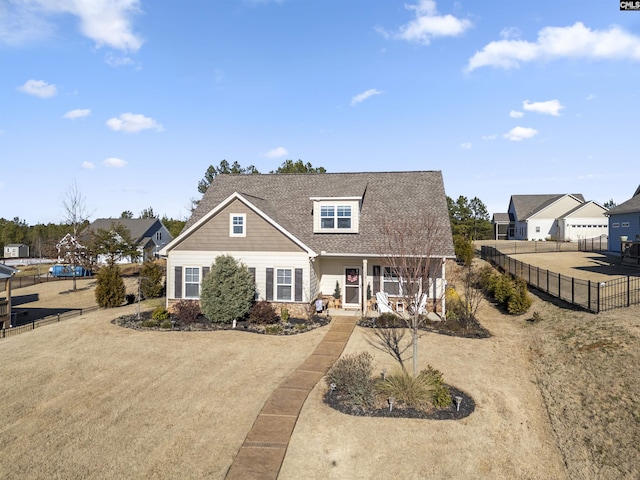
[481,246,640,313]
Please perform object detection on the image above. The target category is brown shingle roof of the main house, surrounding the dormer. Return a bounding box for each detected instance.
[179,171,455,257]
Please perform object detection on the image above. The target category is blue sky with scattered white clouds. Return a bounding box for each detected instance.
[0,0,640,225]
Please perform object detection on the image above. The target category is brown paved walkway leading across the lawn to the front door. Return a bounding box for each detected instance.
[225,316,358,480]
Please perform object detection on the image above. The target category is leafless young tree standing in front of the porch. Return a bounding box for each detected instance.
[379,214,444,375]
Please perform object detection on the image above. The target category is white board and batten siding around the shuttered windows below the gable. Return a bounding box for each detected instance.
[167,250,312,302]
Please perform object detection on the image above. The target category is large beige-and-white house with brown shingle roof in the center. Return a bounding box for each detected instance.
[161,171,455,314]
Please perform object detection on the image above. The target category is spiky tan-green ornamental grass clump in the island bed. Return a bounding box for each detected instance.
[376,370,435,410]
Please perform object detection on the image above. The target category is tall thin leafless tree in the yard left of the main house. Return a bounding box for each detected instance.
[62,180,90,291]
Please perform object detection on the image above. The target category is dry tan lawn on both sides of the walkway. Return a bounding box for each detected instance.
[0,272,640,480]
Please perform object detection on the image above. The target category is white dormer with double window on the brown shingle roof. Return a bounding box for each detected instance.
[312,197,360,233]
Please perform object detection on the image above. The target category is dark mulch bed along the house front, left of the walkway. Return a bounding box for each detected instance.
[111,311,331,335]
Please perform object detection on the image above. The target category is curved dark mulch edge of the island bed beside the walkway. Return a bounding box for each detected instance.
[324,385,476,420]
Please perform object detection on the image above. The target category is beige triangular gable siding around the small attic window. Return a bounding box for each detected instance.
[173,200,303,252]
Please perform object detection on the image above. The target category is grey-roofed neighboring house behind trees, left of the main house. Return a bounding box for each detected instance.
[87,218,173,263]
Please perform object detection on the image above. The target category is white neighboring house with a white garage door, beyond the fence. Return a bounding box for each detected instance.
[496,193,607,242]
